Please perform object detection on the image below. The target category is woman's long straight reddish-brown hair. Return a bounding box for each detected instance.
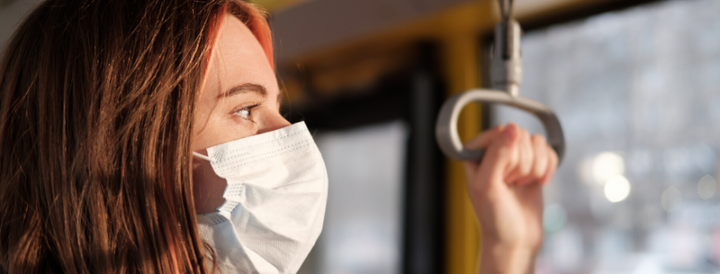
[0,0,273,273]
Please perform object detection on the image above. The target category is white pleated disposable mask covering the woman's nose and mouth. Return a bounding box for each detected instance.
[195,122,328,273]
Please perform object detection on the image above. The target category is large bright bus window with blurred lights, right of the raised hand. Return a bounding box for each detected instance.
[494,0,720,273]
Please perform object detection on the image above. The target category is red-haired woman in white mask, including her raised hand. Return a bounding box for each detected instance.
[0,0,557,273]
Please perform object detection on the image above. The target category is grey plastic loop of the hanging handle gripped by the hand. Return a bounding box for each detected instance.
[435,89,565,165]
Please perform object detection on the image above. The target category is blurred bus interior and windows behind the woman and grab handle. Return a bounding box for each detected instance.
[0,0,720,274]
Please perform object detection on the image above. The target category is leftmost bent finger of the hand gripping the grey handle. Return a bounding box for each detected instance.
[476,123,519,190]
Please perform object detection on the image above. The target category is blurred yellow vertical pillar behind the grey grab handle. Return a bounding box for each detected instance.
[428,1,495,274]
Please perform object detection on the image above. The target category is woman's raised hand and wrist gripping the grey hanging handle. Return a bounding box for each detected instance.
[465,123,558,273]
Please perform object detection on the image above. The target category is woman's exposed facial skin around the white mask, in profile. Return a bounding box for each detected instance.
[192,14,290,213]
